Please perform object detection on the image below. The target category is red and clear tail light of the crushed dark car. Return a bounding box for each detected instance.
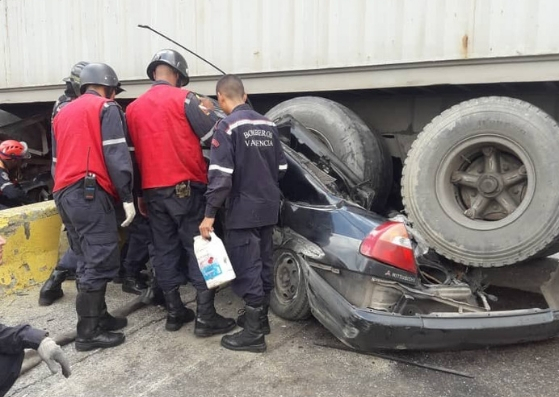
[359,221,417,274]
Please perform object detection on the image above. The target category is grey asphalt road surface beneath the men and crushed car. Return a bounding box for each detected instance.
[0,282,559,397]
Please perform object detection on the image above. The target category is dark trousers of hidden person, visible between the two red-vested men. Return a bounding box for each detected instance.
[123,214,155,277]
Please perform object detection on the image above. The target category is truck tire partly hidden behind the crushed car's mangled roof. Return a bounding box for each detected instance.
[266,97,392,212]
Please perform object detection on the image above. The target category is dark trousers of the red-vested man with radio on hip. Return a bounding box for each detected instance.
[54,182,119,291]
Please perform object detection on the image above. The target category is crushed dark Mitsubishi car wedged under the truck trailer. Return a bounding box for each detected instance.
[270,116,559,351]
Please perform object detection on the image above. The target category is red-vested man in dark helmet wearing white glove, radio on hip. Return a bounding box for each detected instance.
[53,63,136,351]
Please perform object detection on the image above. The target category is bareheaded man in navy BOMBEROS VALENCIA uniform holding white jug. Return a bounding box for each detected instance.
[200,75,287,352]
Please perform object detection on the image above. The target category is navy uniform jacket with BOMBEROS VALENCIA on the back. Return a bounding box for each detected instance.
[205,104,287,229]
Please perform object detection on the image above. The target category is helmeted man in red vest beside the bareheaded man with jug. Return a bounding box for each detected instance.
[126,50,235,336]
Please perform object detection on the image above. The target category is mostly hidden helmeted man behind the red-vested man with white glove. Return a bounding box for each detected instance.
[39,61,89,306]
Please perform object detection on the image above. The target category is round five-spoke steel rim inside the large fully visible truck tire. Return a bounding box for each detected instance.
[435,133,536,230]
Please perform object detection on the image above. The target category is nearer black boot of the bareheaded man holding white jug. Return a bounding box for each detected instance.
[221,305,266,353]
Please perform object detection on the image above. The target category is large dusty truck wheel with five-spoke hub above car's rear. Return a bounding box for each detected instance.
[402,97,559,267]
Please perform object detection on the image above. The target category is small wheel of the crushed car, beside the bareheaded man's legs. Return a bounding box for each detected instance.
[270,248,311,321]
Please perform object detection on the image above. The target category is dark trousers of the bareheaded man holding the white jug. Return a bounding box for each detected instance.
[225,226,274,306]
